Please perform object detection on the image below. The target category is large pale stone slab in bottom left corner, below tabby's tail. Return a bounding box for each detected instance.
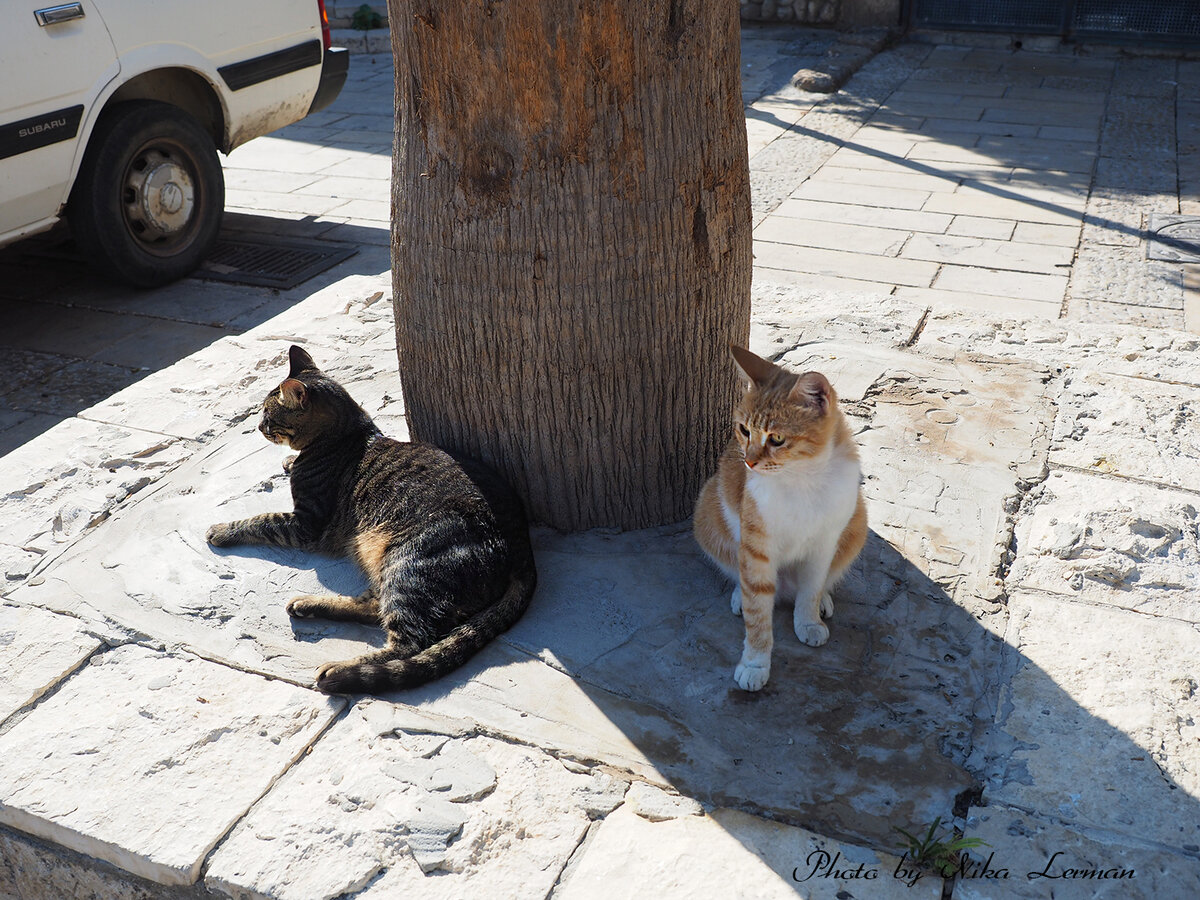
[0,646,344,884]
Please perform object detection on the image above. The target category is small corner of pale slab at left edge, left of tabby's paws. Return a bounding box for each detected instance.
[0,605,102,722]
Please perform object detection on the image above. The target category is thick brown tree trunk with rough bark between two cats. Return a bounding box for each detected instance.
[389,0,752,530]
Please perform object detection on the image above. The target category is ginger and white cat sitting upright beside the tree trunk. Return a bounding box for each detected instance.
[694,347,866,691]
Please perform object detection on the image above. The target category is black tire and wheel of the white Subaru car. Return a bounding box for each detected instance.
[67,101,224,288]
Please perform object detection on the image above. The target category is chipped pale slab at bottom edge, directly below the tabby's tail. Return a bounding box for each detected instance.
[205,701,609,900]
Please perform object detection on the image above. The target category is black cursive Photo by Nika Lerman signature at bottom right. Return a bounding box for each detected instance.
[792,850,1138,887]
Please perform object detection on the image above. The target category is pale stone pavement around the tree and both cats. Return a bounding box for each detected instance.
[0,29,1200,900]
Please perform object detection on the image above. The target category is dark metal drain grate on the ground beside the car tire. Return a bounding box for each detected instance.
[192,232,359,290]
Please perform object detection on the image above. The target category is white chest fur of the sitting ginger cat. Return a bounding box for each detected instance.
[745,451,860,565]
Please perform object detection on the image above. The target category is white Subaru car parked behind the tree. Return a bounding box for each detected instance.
[0,0,349,287]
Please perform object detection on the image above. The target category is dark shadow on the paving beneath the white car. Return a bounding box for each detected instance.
[0,212,389,456]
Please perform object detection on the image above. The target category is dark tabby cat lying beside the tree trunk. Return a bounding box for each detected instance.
[208,347,536,694]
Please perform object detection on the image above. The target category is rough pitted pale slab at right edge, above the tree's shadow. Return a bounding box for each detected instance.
[1009,472,1200,623]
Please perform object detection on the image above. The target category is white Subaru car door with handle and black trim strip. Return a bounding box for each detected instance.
[0,0,120,242]
